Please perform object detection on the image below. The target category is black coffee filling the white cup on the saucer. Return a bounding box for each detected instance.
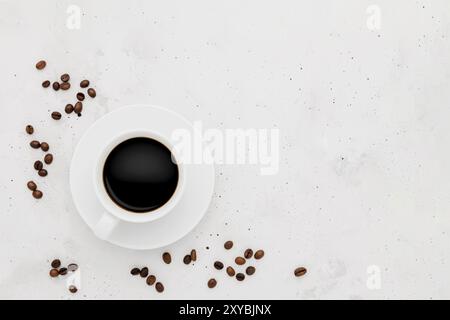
[103,137,179,213]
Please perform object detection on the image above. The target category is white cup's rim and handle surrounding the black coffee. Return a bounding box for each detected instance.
[93,129,185,240]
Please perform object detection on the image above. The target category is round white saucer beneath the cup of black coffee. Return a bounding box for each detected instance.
[70,105,214,250]
